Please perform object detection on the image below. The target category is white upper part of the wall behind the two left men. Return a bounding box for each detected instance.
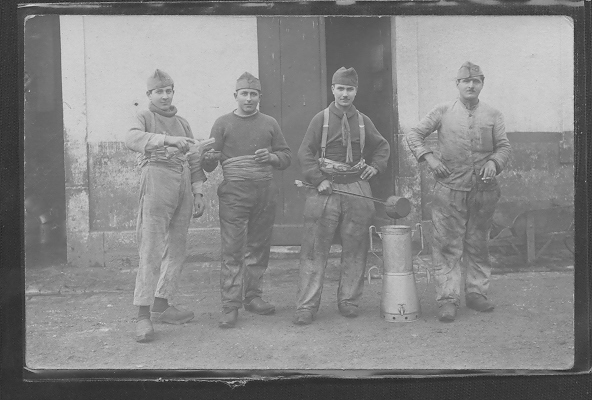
[60,15,258,142]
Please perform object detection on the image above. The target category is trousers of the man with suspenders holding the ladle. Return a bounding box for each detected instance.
[296,181,375,313]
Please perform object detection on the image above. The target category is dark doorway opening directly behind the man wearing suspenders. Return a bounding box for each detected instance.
[325,17,397,226]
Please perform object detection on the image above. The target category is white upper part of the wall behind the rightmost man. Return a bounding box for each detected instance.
[393,16,574,132]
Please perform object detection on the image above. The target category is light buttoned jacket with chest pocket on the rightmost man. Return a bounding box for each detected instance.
[406,99,511,191]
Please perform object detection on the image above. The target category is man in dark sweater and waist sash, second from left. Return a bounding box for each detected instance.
[204,72,292,328]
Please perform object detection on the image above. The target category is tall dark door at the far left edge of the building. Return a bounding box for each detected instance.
[23,15,66,266]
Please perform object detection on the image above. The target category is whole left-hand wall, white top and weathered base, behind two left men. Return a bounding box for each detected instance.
[60,16,258,264]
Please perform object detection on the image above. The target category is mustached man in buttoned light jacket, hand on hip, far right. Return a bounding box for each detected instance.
[406,61,511,322]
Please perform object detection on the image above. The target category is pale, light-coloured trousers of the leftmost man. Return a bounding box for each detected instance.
[134,163,193,306]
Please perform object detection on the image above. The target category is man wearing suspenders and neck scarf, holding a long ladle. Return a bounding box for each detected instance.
[293,67,390,325]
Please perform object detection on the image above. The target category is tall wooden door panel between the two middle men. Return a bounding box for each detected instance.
[257,17,326,245]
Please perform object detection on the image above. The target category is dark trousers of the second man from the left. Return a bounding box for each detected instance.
[218,180,277,308]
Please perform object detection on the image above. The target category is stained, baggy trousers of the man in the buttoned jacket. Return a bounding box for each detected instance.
[432,183,500,305]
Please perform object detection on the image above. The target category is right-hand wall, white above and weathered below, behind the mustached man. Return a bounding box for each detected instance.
[392,16,574,228]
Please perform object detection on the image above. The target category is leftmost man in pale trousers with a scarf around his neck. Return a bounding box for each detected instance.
[125,69,206,342]
